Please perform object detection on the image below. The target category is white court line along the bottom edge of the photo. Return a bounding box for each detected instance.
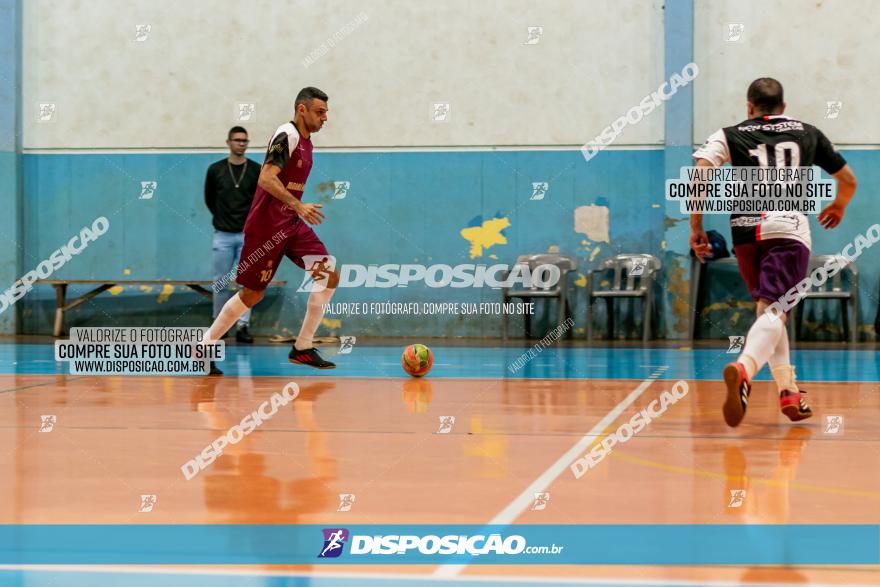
[0,565,876,587]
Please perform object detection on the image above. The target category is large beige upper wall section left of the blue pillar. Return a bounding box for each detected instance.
[23,0,663,149]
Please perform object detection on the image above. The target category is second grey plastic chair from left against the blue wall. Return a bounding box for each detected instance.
[587,254,660,342]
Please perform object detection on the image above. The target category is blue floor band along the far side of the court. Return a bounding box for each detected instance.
[0,343,880,383]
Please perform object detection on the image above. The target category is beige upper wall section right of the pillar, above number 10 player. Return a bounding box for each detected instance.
[694,0,880,145]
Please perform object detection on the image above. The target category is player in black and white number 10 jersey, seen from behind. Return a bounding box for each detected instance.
[690,77,856,426]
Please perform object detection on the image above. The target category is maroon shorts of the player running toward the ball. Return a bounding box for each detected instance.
[235,220,330,291]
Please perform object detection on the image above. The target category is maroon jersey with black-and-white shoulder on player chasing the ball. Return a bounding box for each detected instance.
[244,122,312,236]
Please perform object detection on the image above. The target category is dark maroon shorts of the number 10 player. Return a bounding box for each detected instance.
[733,238,810,303]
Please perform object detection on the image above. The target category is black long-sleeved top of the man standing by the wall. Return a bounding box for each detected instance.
[205,159,260,232]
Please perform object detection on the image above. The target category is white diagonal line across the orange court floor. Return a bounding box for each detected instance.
[434,365,669,577]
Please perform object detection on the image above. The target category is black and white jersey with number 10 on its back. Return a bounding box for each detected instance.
[693,115,846,248]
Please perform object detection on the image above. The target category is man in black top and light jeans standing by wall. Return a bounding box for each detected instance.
[205,126,260,343]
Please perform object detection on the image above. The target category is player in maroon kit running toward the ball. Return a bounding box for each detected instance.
[202,87,339,374]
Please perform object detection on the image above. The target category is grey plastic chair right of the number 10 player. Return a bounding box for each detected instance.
[789,255,859,342]
